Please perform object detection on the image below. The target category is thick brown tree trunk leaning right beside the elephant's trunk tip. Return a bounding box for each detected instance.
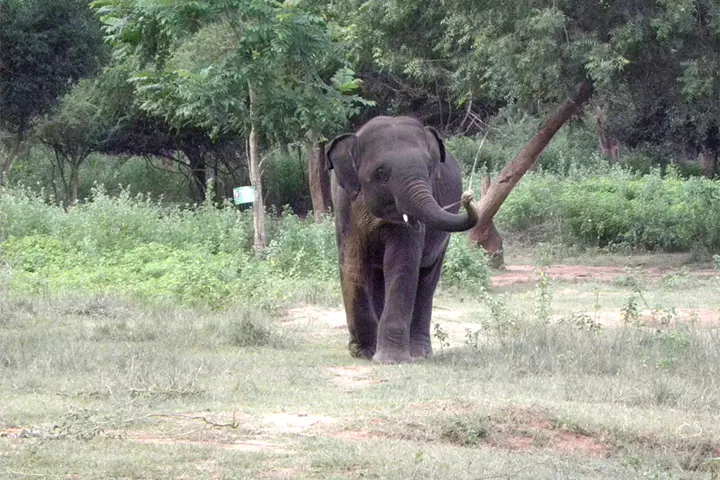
[470,80,594,264]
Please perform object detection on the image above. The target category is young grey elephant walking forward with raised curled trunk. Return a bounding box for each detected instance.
[326,116,478,363]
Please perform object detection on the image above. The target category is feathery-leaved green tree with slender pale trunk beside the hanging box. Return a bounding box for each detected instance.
[93,0,366,250]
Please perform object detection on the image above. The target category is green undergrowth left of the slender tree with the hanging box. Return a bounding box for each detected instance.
[0,186,256,307]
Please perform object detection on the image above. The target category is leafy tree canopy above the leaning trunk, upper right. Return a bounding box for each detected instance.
[334,0,720,150]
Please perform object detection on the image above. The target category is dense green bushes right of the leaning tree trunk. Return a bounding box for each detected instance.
[498,169,720,251]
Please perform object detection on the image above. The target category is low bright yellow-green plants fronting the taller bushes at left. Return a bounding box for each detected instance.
[2,235,250,307]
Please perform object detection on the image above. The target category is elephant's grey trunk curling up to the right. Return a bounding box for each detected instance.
[396,179,478,232]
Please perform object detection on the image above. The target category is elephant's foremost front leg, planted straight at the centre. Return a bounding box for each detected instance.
[373,230,422,363]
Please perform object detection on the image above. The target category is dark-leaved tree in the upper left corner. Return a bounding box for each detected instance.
[0,0,104,185]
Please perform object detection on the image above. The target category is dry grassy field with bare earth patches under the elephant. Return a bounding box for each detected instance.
[0,252,720,479]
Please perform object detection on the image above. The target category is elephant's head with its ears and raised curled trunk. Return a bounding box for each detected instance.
[327,117,478,232]
